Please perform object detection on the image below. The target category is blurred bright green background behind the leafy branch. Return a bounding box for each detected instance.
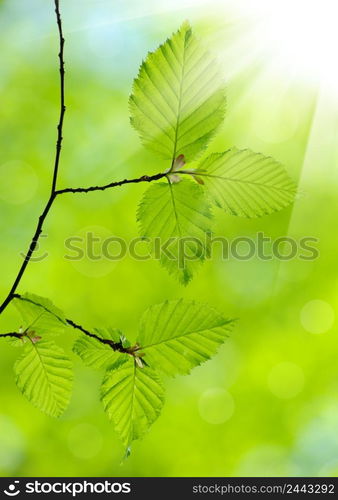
[0,0,338,476]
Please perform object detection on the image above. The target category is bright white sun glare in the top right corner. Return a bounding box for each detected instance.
[226,0,338,90]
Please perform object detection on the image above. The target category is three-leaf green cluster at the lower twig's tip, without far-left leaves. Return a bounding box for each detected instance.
[73,299,234,447]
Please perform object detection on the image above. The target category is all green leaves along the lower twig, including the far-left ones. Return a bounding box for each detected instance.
[10,294,234,449]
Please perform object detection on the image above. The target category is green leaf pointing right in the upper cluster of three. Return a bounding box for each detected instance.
[197,148,296,217]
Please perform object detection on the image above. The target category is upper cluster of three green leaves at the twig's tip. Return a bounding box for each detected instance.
[130,22,296,284]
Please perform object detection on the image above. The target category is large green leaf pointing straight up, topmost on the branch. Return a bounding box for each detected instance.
[129,22,225,162]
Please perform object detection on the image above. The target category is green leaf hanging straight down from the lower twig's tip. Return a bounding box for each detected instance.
[101,359,164,447]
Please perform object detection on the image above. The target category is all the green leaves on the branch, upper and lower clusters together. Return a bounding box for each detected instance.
[3,23,296,449]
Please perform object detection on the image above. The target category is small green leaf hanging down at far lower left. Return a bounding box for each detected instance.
[14,339,73,417]
